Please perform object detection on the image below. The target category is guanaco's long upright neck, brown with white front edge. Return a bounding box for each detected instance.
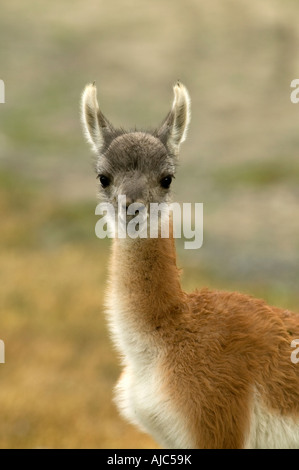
[108,229,184,346]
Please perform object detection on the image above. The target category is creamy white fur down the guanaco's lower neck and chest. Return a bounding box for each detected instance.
[108,294,193,448]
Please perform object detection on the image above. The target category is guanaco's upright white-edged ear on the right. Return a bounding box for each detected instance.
[157,81,191,155]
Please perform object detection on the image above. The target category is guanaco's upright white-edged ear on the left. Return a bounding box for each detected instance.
[81,83,113,152]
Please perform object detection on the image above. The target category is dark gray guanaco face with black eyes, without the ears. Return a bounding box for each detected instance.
[96,132,175,207]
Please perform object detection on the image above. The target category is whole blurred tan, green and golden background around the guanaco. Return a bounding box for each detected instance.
[0,0,299,448]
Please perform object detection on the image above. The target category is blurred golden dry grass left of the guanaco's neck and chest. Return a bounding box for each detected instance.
[0,250,159,448]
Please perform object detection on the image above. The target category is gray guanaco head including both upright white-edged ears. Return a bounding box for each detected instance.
[82,82,190,207]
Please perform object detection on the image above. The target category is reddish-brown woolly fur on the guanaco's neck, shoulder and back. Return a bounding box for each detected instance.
[110,231,299,448]
